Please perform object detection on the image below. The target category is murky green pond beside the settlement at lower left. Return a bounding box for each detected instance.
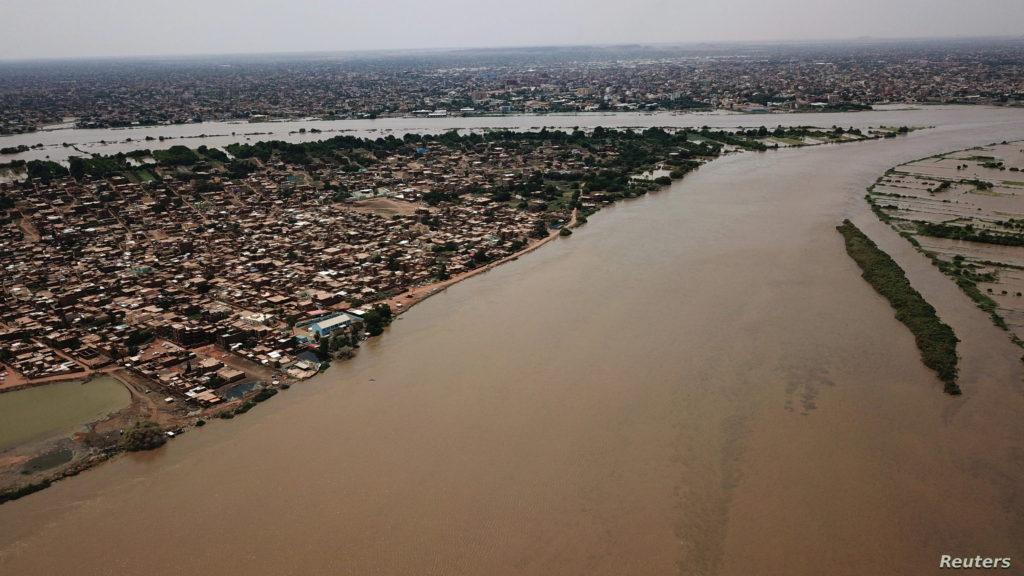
[0,376,131,451]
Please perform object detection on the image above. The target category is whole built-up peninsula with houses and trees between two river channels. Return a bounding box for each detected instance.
[0,123,907,501]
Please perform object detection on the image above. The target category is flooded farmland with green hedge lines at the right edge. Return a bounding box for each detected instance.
[866,141,1024,352]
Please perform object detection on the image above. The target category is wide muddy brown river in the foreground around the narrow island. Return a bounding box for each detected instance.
[0,109,1024,576]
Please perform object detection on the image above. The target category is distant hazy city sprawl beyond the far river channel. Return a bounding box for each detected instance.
[0,39,1024,133]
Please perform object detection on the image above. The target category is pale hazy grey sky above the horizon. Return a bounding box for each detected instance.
[0,0,1024,59]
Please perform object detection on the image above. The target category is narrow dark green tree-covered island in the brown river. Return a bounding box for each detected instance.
[836,220,961,396]
